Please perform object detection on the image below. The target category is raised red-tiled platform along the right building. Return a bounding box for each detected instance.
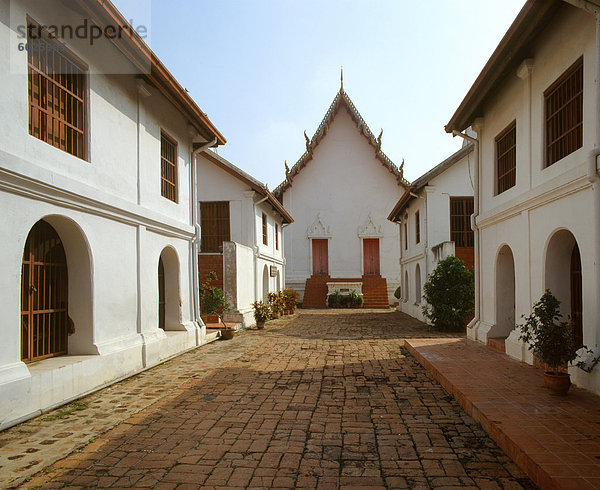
[406,339,600,489]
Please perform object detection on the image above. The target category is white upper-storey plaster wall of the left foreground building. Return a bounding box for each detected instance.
[0,0,191,224]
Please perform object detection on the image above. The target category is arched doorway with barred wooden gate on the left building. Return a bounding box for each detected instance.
[21,220,69,362]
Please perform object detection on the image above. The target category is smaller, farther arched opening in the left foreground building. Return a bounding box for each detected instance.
[158,247,183,330]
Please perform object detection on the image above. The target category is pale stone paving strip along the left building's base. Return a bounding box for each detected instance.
[0,317,291,488]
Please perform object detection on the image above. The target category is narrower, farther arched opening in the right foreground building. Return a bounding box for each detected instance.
[494,245,515,337]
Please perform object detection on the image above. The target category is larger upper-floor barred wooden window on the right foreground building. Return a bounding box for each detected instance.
[544,56,584,167]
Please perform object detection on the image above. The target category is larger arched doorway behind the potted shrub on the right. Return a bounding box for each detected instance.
[544,229,583,347]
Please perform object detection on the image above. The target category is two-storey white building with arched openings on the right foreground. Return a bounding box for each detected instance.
[446,0,600,392]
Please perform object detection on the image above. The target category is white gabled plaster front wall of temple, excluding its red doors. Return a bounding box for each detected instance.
[283,108,404,293]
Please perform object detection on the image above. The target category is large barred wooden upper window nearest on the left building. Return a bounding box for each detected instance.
[27,16,89,160]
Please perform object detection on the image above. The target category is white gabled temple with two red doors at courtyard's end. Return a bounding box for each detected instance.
[274,78,408,308]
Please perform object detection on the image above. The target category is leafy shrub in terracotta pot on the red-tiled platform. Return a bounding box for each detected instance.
[519,289,577,395]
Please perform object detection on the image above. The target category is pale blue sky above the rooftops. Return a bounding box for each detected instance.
[113,0,524,189]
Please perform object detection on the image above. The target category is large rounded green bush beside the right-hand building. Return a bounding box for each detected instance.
[422,255,475,331]
